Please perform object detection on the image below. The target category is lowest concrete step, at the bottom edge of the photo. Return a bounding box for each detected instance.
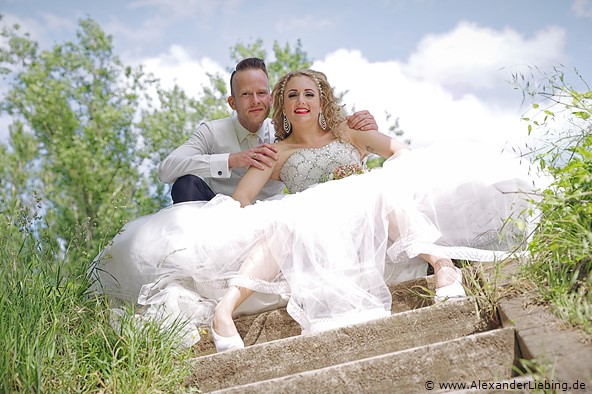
[212,328,514,394]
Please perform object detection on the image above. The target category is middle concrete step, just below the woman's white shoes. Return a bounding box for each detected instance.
[190,299,494,391]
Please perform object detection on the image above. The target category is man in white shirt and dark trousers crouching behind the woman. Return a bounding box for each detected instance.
[159,58,378,204]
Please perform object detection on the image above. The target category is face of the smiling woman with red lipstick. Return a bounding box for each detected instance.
[284,75,321,126]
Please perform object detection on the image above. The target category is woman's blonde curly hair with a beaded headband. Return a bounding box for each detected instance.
[272,70,345,142]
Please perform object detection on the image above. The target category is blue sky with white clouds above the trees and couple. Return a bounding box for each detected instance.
[0,0,592,146]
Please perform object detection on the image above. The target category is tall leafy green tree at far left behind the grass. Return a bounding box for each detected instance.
[0,19,155,259]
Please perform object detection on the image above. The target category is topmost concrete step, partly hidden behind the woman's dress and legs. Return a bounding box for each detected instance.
[194,276,434,356]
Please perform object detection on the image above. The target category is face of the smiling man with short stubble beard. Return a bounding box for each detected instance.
[228,69,270,132]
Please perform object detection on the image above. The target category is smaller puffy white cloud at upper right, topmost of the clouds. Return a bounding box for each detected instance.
[404,22,566,89]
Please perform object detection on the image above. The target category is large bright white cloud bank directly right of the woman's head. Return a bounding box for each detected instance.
[313,50,526,147]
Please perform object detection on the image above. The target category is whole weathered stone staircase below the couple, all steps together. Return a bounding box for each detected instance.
[188,276,530,393]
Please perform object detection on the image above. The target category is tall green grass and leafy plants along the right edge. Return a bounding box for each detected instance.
[508,68,592,334]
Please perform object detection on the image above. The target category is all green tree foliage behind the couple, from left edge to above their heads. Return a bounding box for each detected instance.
[0,18,311,261]
